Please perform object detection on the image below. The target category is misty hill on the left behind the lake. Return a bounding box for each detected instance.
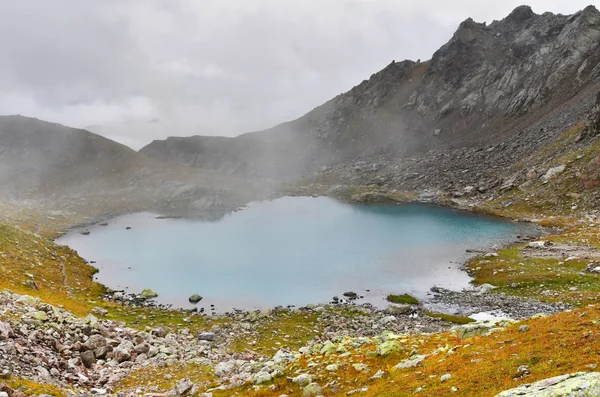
[0,116,264,213]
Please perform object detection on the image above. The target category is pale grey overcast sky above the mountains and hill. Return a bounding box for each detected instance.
[0,0,591,149]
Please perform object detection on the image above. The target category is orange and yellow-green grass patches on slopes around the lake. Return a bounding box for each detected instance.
[0,126,600,396]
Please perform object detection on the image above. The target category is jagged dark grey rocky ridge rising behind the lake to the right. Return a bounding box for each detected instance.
[141,6,600,178]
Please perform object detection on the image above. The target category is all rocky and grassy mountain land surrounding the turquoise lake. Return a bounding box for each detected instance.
[0,3,600,397]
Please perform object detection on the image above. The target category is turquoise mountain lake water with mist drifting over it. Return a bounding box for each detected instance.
[57,197,531,312]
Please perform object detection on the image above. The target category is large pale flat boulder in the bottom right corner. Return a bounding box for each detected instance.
[496,372,600,397]
